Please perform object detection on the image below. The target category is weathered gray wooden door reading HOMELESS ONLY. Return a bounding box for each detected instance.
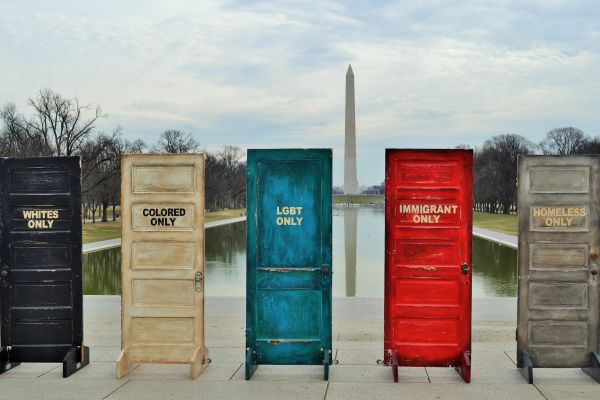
[517,156,600,368]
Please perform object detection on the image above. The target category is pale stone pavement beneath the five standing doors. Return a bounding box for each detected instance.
[0,296,600,400]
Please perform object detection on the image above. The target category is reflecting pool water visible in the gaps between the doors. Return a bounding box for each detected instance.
[83,207,517,298]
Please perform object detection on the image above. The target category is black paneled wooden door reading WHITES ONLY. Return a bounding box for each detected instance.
[0,157,88,376]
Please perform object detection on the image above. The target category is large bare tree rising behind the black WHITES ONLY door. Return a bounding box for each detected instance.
[0,89,125,219]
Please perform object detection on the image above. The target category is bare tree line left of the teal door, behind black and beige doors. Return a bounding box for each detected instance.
[0,89,246,222]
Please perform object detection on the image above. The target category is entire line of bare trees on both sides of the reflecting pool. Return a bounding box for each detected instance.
[0,89,600,222]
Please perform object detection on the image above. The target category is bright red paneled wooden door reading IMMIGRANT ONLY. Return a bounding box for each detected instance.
[384,149,473,382]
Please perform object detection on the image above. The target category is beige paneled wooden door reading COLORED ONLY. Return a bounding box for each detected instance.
[117,154,207,379]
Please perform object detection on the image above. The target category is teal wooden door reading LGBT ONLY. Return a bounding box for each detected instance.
[246,149,332,379]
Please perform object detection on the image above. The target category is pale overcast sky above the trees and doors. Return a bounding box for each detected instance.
[0,0,600,185]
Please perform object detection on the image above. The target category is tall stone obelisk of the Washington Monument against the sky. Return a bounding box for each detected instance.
[344,65,358,194]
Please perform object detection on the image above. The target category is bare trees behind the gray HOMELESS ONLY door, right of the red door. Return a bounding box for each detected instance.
[474,127,600,214]
